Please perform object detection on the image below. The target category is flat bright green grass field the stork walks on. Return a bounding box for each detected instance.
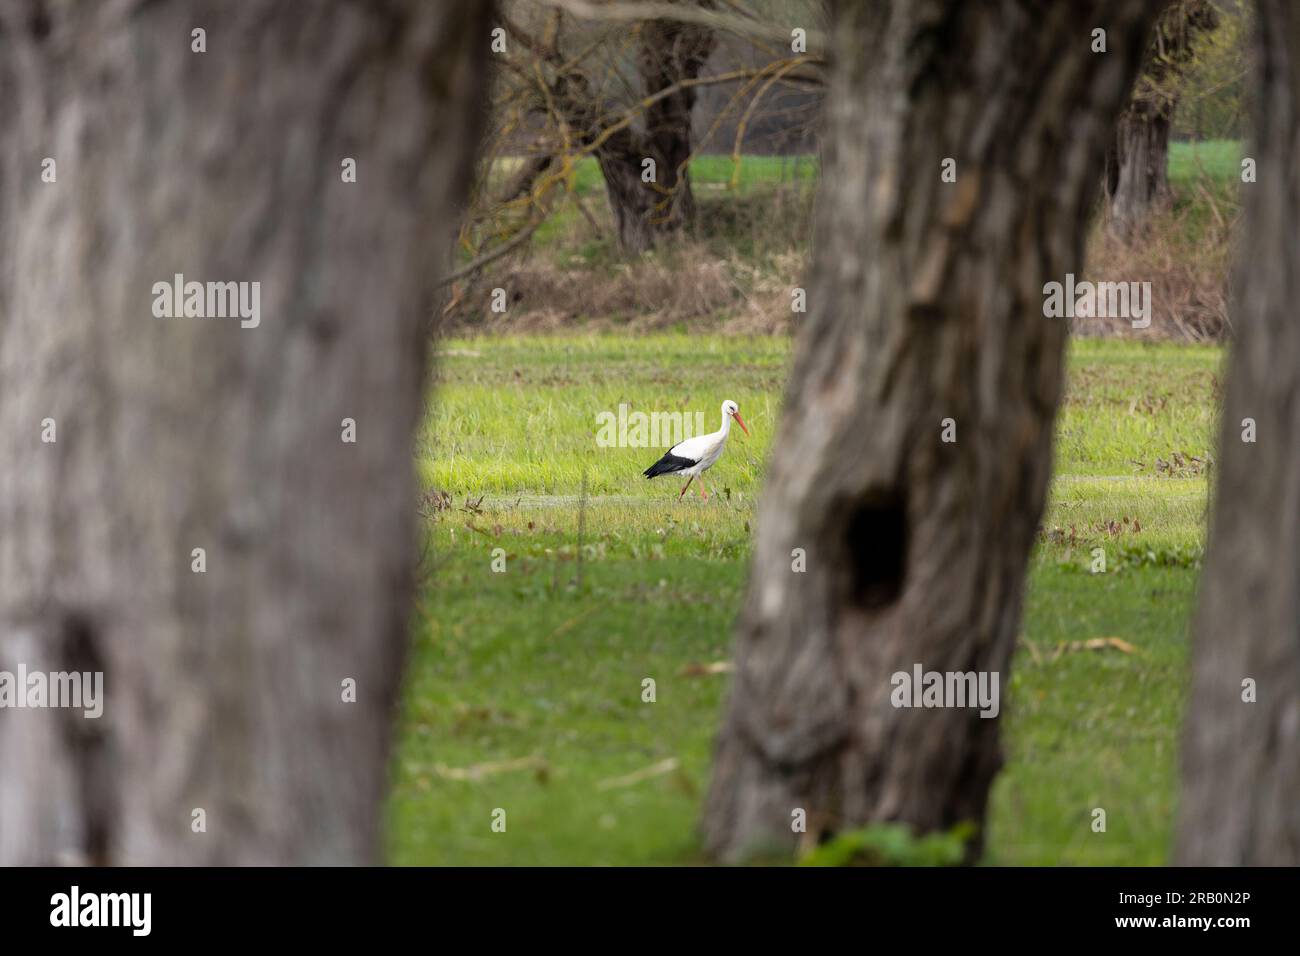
[389,336,1221,865]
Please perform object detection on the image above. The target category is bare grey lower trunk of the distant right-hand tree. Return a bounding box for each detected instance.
[1106,103,1174,237]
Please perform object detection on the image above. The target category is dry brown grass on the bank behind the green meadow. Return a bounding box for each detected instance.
[446,179,1238,341]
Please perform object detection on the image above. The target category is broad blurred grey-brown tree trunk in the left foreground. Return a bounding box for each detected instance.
[0,0,489,864]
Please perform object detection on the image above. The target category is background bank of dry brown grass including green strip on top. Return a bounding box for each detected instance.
[465,140,1242,341]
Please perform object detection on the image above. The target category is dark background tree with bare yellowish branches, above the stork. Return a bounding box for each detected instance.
[458,0,819,274]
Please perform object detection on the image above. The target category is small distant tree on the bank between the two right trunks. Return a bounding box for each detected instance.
[1105,0,1219,237]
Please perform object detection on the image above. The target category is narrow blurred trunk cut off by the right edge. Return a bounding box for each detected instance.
[1177,0,1300,866]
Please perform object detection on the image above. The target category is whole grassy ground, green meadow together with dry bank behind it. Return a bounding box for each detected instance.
[389,142,1242,865]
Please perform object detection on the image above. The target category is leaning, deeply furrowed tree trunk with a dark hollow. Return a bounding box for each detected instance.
[703,0,1160,861]
